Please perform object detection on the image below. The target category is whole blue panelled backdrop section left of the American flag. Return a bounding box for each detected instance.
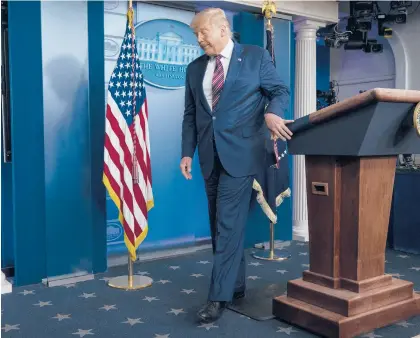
[2,1,106,285]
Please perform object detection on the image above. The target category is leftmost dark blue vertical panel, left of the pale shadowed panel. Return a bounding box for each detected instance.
[7,1,46,285]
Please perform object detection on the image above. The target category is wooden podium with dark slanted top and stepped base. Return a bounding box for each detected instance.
[273,89,420,338]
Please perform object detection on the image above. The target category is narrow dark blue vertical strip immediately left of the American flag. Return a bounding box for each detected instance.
[88,1,107,273]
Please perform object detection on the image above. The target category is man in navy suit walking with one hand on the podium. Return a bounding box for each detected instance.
[180,8,292,322]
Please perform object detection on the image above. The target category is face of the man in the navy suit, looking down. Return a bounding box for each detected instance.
[194,22,224,56]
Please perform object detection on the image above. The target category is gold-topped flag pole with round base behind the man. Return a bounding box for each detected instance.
[252,0,291,261]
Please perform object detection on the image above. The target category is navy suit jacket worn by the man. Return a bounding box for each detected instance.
[182,43,289,179]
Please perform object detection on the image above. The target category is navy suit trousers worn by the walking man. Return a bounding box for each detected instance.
[205,144,254,302]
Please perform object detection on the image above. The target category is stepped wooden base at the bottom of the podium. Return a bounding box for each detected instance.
[273,280,420,338]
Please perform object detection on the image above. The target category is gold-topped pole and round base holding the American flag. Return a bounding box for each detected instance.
[108,0,153,290]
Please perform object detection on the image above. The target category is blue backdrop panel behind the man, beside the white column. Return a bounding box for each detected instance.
[233,13,294,247]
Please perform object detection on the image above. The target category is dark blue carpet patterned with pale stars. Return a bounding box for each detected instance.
[1,242,420,338]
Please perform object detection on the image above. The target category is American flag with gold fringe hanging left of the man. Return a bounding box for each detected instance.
[103,9,154,260]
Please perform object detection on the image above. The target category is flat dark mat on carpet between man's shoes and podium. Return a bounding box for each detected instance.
[228,284,286,321]
